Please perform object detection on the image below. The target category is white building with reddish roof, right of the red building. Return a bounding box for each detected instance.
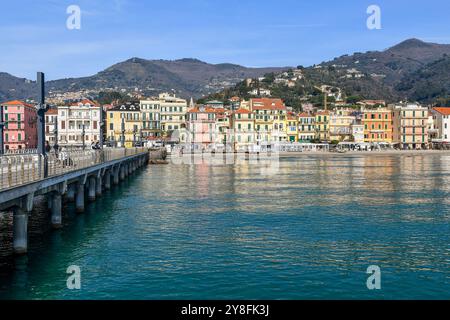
[58,99,102,147]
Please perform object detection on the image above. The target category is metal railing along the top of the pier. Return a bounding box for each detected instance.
[0,148,148,191]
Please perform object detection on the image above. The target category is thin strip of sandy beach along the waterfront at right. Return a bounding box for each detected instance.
[280,150,450,157]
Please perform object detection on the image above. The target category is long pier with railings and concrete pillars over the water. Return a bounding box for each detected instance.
[0,148,149,254]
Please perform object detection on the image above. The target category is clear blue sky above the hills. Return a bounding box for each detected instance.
[0,0,450,79]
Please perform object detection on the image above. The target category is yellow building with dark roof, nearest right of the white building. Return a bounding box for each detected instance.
[106,103,142,148]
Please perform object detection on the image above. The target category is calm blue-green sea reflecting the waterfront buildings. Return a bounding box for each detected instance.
[0,154,450,299]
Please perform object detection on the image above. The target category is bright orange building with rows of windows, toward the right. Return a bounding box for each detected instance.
[362,108,393,143]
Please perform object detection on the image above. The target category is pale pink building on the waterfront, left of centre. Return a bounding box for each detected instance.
[186,106,219,149]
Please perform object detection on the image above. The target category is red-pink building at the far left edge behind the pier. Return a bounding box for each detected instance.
[2,100,37,150]
